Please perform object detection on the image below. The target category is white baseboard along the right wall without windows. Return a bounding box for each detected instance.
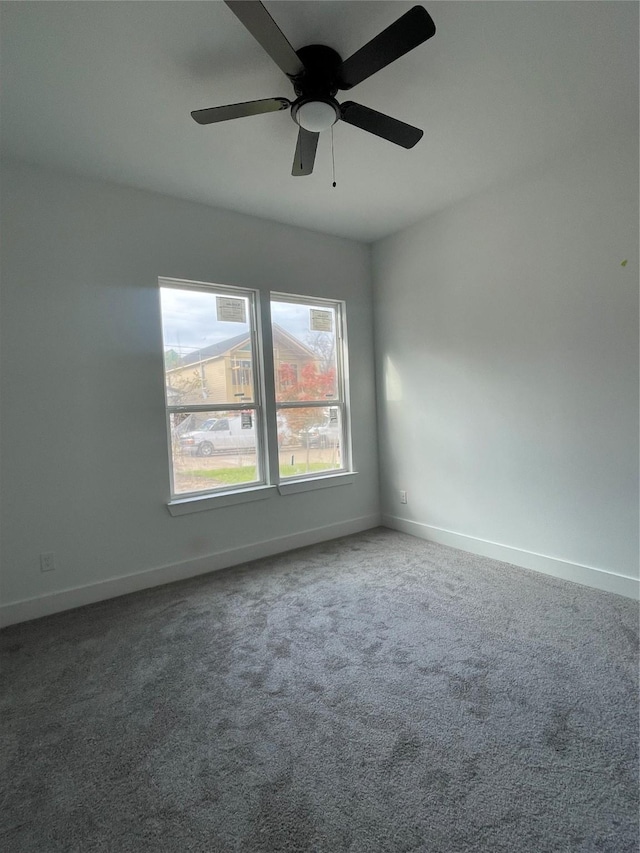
[382,515,640,599]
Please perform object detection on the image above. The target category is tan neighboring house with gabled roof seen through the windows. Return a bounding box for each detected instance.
[166,324,319,405]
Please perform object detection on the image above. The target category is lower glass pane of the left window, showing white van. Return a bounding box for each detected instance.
[169,409,260,494]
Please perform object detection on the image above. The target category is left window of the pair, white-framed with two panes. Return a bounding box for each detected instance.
[160,280,265,497]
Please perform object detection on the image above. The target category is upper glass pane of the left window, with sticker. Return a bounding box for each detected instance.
[160,287,255,406]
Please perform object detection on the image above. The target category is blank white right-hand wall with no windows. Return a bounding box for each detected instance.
[373,129,638,594]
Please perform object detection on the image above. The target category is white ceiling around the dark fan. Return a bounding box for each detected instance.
[0,0,638,241]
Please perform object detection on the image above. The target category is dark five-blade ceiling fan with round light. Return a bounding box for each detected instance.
[191,0,436,176]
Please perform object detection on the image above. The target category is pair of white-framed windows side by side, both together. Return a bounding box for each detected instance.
[160,279,350,500]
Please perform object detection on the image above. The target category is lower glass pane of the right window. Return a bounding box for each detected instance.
[278,406,343,477]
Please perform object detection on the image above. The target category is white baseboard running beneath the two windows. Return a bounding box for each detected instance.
[0,514,380,627]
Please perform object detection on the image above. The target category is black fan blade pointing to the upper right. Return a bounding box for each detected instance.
[340,6,436,89]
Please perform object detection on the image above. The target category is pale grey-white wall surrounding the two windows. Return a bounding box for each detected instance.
[1,163,379,621]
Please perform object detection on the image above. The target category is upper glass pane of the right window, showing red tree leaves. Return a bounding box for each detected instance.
[271,299,338,403]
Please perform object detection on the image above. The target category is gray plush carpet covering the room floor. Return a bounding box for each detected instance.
[0,529,638,853]
